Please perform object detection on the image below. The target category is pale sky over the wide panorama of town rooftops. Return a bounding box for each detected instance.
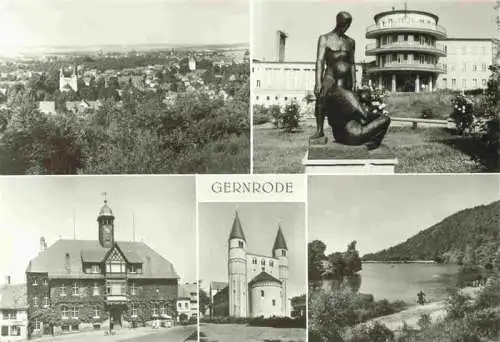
[0,0,249,52]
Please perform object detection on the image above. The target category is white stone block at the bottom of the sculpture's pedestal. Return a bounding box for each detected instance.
[302,152,398,175]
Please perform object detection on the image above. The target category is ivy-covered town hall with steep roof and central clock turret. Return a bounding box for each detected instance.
[26,201,179,336]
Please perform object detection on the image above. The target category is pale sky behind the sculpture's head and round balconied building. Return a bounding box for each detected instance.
[253,0,499,61]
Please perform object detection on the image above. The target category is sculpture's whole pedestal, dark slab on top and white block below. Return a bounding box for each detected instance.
[302,139,398,175]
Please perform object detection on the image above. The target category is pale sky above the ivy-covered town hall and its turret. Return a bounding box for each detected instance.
[0,176,196,282]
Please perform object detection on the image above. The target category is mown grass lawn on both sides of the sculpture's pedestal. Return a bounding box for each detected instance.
[253,124,492,173]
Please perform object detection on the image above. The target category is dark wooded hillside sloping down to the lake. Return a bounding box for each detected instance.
[363,201,500,265]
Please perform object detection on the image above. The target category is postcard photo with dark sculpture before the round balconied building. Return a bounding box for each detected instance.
[252,0,500,173]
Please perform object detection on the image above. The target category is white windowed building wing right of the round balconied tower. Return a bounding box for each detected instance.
[437,38,500,90]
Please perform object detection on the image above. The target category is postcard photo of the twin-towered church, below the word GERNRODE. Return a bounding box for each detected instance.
[198,203,307,342]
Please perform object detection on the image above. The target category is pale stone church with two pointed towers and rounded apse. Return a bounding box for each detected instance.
[228,213,290,317]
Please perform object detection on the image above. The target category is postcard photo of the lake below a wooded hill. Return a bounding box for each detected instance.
[308,175,500,342]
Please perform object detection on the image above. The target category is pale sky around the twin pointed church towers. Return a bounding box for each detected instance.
[198,203,307,297]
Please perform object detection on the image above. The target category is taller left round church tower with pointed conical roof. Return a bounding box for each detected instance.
[228,213,248,317]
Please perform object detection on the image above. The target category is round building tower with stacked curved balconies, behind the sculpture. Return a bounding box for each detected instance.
[366,9,446,92]
